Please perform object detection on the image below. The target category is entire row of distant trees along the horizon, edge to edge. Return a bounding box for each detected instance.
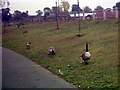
[2,1,120,22]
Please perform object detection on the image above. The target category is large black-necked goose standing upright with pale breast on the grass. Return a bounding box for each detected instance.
[80,43,91,65]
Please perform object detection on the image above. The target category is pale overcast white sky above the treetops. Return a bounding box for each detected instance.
[8,0,120,15]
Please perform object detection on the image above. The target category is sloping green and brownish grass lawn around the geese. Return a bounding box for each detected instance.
[2,20,118,88]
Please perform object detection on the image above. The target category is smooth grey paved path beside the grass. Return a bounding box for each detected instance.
[2,48,76,88]
